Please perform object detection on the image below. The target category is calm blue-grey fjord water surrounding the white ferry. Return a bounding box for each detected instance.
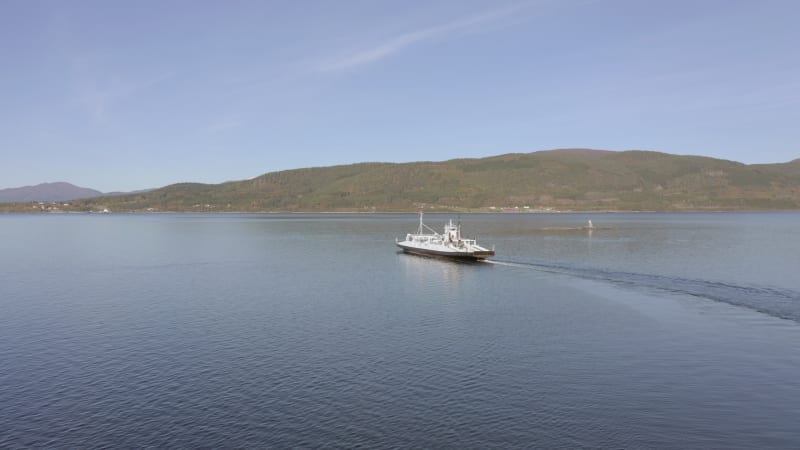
[0,213,800,449]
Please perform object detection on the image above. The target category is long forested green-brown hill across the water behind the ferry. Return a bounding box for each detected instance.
[4,149,800,212]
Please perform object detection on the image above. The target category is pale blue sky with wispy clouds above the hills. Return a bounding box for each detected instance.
[0,0,800,192]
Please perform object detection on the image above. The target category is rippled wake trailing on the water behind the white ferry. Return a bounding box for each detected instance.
[486,260,800,323]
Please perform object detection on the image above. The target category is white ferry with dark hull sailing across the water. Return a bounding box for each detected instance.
[396,213,494,261]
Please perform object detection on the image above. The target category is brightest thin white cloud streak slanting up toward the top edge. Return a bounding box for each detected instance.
[319,3,530,72]
